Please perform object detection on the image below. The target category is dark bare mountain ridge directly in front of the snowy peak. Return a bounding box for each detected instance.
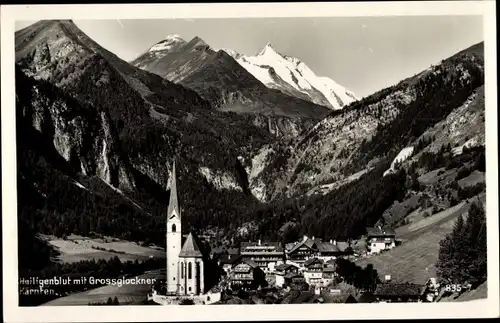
[132,37,328,120]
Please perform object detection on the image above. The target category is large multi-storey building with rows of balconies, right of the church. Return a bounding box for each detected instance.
[240,240,284,273]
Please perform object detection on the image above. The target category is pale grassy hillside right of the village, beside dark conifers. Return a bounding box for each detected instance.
[356,193,486,283]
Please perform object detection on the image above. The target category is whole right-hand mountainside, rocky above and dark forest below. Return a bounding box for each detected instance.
[229,43,486,246]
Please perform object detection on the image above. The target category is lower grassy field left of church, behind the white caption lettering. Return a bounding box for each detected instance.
[42,270,165,306]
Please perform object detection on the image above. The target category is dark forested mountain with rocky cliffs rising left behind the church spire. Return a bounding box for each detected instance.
[16,21,286,244]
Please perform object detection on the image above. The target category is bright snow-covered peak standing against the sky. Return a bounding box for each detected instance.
[225,43,358,110]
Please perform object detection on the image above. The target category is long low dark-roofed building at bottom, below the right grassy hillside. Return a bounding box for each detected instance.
[373,283,427,303]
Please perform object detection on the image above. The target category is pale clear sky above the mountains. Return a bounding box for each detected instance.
[16,15,483,98]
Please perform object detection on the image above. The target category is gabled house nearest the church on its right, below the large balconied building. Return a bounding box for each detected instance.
[229,258,266,289]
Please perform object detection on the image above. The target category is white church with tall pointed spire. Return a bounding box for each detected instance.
[166,161,208,296]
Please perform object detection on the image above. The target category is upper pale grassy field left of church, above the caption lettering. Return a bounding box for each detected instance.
[43,235,165,262]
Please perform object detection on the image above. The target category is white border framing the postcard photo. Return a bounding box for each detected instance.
[1,0,500,322]
